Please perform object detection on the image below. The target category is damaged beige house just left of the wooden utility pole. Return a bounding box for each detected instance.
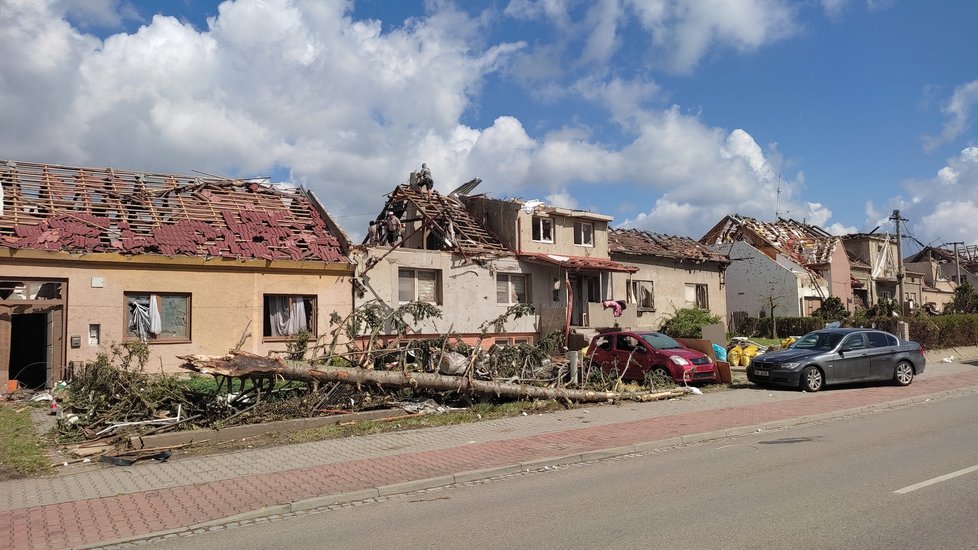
[842,233,924,308]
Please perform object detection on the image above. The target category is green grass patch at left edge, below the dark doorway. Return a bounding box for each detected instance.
[0,406,51,479]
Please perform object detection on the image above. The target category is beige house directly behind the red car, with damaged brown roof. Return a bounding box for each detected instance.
[608,229,730,330]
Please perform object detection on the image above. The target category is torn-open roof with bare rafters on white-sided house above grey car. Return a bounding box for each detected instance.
[700,214,839,266]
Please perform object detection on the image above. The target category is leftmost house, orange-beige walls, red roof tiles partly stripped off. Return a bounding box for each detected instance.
[0,161,352,388]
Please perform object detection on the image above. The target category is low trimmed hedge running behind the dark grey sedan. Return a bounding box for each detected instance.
[735,314,978,349]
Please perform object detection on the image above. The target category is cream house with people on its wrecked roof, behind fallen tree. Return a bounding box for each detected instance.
[351,181,539,345]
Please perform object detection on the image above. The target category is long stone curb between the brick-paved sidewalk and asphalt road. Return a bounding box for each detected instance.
[73,386,978,550]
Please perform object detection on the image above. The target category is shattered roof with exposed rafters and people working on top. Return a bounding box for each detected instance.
[377,185,512,256]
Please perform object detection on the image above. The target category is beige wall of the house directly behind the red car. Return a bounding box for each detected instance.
[612,254,727,330]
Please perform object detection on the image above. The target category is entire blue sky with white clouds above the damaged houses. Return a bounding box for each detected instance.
[0,0,978,250]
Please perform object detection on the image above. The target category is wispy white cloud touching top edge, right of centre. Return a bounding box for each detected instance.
[625,0,798,72]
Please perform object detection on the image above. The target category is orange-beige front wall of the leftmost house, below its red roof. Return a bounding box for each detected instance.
[0,250,353,384]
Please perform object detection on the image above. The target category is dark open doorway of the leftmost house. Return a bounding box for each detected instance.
[7,313,50,390]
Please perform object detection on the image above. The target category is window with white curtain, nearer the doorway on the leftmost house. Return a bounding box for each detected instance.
[125,292,190,342]
